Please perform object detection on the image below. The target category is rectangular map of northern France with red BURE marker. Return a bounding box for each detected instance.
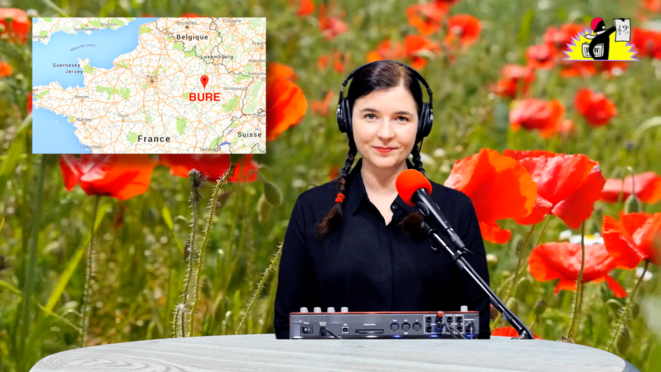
[32,18,266,154]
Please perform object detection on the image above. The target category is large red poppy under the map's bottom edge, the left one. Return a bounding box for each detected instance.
[60,154,158,200]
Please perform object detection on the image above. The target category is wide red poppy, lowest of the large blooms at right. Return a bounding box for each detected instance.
[528,242,627,297]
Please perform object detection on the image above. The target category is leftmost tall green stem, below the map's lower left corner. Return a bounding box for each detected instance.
[18,155,46,369]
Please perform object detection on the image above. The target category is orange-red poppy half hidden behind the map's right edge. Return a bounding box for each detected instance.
[266,70,308,141]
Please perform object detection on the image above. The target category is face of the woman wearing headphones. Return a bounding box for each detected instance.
[352,85,418,168]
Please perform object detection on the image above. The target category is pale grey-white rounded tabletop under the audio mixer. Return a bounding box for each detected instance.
[31,334,639,372]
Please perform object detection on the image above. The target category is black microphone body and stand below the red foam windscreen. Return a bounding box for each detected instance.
[416,206,533,340]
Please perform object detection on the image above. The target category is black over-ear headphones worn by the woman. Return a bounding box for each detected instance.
[337,60,434,145]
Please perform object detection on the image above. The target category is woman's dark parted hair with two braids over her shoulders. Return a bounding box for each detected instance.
[314,61,425,240]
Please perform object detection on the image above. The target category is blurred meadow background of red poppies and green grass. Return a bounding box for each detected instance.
[0,0,661,372]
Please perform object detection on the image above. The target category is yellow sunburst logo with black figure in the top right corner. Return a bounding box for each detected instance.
[564,17,638,61]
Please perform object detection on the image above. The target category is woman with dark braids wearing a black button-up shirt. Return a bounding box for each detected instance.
[274,61,490,338]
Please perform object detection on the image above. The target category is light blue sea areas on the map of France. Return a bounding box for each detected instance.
[32,18,158,154]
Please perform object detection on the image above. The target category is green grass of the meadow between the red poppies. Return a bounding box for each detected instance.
[0,0,661,372]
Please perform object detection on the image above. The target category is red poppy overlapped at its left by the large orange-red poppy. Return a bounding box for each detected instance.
[503,150,606,229]
